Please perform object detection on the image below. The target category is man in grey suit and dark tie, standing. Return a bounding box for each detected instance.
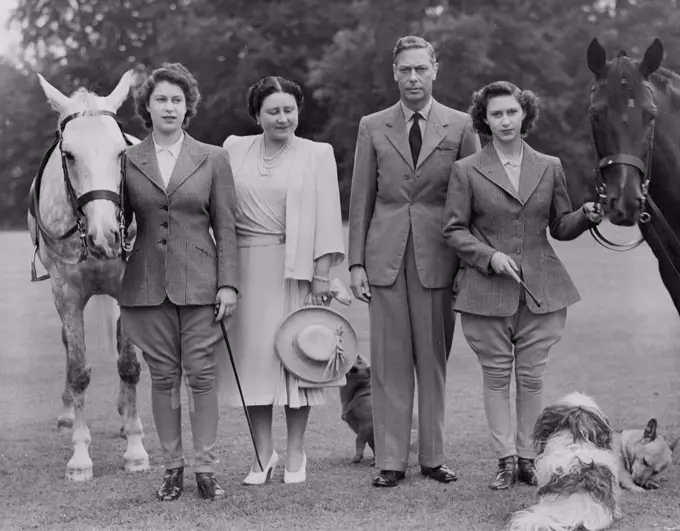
[348,36,480,487]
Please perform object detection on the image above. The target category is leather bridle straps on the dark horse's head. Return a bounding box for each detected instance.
[589,80,658,252]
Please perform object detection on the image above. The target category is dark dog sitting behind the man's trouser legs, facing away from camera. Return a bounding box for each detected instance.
[340,355,418,466]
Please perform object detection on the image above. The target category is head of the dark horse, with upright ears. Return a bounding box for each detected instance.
[588,39,663,225]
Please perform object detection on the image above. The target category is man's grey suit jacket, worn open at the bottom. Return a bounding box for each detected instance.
[348,101,480,289]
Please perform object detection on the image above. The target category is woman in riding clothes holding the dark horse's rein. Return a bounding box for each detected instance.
[443,81,601,490]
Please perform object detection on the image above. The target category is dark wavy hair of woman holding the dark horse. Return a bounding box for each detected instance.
[468,81,539,136]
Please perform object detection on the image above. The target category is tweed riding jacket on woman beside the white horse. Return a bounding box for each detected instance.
[119,133,238,306]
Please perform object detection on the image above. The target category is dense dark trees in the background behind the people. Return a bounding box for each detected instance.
[0,0,680,228]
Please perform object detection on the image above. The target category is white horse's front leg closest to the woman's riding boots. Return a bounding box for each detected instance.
[116,317,149,472]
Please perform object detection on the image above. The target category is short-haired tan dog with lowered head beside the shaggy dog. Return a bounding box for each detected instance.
[613,419,678,492]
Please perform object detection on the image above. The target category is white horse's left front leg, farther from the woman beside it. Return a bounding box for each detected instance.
[52,279,92,481]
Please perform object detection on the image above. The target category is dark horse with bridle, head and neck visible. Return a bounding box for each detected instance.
[587,39,680,313]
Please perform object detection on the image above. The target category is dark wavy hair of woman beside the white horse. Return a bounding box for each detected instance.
[135,63,201,129]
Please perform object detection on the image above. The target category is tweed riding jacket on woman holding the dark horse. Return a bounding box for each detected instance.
[443,142,591,316]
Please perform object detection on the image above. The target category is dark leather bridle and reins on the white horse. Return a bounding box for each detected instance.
[33,110,132,264]
